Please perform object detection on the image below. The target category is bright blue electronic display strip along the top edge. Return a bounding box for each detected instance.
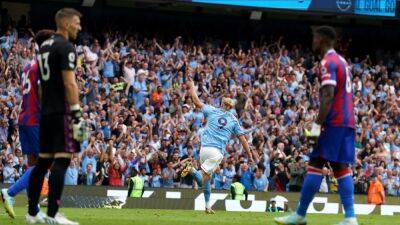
[192,0,398,17]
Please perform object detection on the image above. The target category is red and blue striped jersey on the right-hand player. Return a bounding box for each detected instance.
[319,49,355,128]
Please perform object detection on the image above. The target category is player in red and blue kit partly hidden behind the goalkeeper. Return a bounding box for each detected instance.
[1,30,54,222]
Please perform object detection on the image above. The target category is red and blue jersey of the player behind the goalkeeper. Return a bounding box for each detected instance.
[18,60,40,126]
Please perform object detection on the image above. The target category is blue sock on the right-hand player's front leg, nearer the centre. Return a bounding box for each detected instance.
[297,168,322,216]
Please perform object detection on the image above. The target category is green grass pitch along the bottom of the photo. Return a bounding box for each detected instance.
[0,207,400,225]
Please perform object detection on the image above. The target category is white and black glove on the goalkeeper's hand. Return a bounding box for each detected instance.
[71,105,89,143]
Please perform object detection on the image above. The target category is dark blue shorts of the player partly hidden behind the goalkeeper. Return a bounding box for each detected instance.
[18,125,39,156]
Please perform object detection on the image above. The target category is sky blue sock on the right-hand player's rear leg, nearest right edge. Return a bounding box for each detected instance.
[338,171,355,218]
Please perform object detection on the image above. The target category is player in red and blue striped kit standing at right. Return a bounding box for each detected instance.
[275,26,358,225]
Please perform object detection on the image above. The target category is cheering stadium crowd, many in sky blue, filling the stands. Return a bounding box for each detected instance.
[0,20,400,196]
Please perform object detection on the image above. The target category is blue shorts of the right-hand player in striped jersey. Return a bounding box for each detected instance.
[310,127,356,164]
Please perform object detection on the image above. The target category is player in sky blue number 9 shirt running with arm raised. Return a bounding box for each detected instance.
[182,79,253,214]
